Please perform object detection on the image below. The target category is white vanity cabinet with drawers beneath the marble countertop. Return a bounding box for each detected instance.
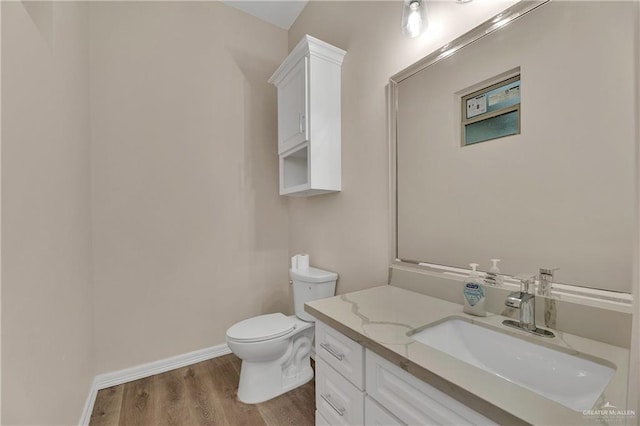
[316,322,496,425]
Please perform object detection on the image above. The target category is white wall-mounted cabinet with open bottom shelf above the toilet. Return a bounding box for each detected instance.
[269,35,346,196]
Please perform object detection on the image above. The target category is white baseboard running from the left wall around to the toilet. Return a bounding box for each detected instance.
[80,343,231,426]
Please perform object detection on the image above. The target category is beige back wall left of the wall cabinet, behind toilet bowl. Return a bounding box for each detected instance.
[89,2,291,373]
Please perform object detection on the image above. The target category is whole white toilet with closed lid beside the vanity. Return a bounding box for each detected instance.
[227,268,338,404]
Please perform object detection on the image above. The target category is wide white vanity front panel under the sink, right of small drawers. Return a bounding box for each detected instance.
[366,350,496,425]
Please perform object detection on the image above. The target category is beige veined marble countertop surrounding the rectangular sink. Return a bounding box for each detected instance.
[305,285,629,425]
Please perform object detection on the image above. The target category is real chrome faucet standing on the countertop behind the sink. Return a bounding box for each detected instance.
[502,274,554,337]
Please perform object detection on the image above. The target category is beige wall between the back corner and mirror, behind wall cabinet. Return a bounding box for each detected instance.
[289,0,515,293]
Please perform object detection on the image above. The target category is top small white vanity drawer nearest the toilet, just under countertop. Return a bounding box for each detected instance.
[316,322,364,390]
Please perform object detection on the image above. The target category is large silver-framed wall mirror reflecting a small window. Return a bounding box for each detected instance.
[391,1,640,293]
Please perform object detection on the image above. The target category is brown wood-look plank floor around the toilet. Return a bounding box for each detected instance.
[90,354,315,426]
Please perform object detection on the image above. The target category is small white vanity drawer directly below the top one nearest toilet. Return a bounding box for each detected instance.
[316,358,364,425]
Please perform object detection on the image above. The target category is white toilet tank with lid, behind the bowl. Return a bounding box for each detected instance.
[289,268,338,322]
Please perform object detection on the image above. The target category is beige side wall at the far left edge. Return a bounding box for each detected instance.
[0,2,94,425]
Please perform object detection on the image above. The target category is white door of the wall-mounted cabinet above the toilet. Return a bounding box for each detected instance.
[278,56,309,154]
